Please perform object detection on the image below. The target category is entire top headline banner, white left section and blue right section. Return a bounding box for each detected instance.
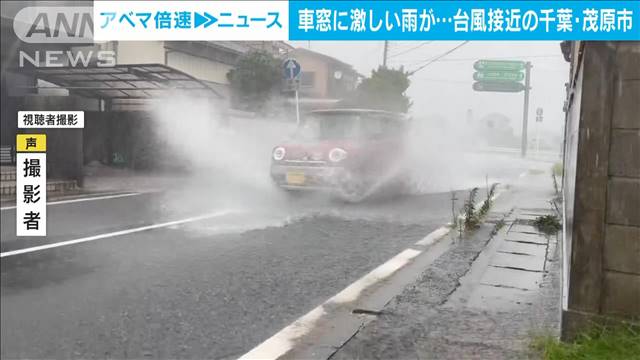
[93,0,640,41]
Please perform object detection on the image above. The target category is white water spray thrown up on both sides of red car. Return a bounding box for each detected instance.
[152,96,528,230]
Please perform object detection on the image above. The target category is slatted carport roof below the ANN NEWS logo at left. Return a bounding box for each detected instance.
[24,64,223,99]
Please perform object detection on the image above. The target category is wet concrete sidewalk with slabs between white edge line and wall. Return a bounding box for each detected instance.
[331,172,561,359]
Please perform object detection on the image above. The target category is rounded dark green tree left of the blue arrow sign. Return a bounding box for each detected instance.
[227,51,282,111]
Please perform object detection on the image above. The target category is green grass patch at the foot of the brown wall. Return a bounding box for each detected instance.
[531,324,640,360]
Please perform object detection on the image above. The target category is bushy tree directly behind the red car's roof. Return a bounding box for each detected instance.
[355,66,411,112]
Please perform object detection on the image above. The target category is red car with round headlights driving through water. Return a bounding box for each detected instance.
[271,109,408,201]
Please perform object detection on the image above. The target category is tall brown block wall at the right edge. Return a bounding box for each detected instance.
[563,42,640,338]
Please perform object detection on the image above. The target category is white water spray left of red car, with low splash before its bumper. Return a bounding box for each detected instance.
[152,96,344,232]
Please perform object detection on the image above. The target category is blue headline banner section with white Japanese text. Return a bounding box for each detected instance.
[289,0,640,40]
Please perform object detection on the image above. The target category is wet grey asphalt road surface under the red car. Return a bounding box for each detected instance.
[1,184,464,359]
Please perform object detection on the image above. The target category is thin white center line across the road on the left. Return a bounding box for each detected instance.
[0,211,234,258]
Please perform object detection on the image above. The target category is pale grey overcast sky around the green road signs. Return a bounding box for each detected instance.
[291,41,569,134]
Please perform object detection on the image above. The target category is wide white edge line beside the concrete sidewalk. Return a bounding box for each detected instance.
[240,232,444,360]
